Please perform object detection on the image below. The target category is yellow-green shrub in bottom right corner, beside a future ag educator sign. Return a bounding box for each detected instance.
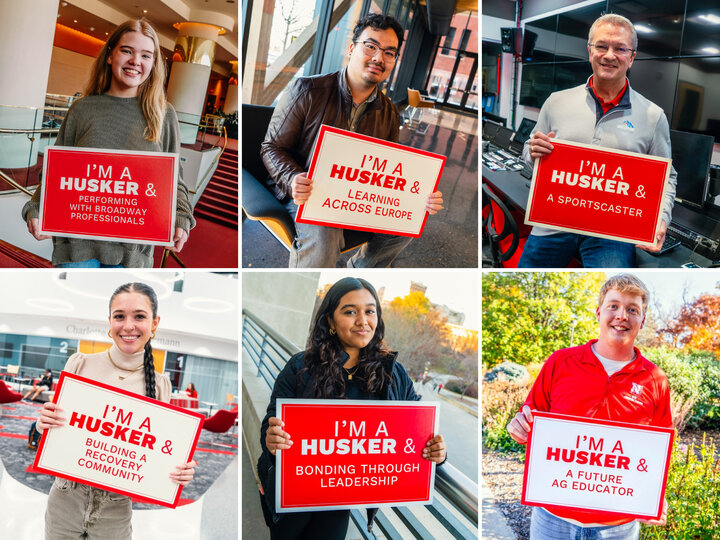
[640,436,720,540]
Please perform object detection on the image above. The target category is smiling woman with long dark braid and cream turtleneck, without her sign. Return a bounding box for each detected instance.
[37,283,197,540]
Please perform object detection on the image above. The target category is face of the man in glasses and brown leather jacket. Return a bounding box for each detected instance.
[347,26,398,90]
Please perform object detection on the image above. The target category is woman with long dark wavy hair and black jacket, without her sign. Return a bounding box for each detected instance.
[253,278,446,540]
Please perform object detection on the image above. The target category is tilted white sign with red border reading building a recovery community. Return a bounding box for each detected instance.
[34,371,203,508]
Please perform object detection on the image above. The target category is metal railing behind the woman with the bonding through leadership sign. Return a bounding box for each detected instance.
[242,309,478,540]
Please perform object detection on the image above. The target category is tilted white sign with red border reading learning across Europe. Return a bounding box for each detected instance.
[296,125,445,237]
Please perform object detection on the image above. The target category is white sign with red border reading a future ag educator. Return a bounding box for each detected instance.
[522,411,675,519]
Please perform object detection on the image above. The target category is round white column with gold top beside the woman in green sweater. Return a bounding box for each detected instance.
[167,22,225,144]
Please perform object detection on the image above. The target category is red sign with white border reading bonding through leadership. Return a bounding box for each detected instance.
[275,399,438,512]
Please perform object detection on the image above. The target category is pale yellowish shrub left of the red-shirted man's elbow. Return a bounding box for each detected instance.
[482,381,530,452]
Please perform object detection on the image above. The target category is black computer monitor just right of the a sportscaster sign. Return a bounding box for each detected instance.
[670,129,715,208]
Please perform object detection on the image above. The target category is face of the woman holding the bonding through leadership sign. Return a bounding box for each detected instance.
[328,289,378,357]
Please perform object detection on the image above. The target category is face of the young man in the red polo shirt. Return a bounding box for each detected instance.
[595,289,645,348]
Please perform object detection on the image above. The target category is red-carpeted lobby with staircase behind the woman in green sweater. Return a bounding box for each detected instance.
[0,0,240,268]
